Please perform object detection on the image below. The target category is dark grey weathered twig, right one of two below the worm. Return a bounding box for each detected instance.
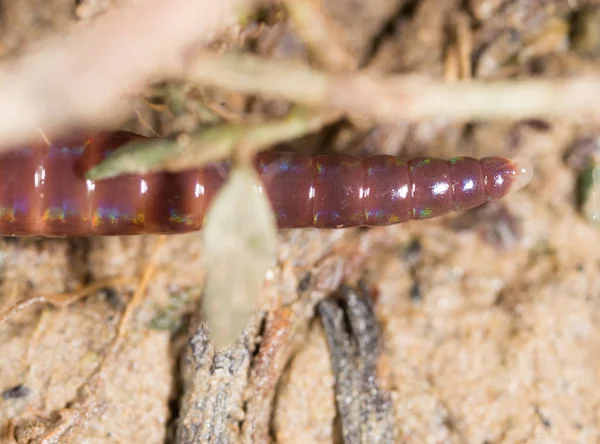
[318,289,394,444]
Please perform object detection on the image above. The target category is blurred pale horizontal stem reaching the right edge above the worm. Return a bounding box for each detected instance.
[181,53,600,123]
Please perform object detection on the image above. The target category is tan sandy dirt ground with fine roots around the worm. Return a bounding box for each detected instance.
[0,0,600,443]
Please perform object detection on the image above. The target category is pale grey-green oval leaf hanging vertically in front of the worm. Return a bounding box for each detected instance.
[203,166,277,348]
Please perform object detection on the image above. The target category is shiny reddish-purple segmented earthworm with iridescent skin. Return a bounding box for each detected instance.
[0,132,516,236]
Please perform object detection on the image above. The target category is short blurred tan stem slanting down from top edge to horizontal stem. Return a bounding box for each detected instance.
[284,0,358,72]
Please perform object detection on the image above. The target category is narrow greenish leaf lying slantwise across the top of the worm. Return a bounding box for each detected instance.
[86,109,337,180]
